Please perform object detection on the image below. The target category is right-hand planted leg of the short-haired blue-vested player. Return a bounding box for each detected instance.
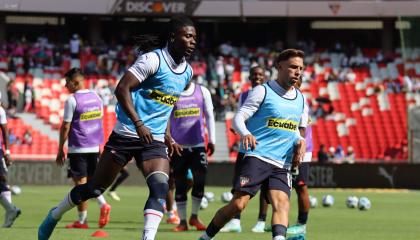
[268,167,292,240]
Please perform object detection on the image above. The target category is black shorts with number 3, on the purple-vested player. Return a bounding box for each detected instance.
[171,147,208,178]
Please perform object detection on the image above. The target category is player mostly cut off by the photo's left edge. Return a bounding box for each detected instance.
[0,99,21,228]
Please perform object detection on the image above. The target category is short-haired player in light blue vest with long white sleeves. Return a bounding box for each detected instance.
[200,49,306,240]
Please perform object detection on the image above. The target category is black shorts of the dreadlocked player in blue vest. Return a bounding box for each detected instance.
[104,132,168,167]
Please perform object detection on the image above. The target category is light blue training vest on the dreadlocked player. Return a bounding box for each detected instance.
[115,49,192,139]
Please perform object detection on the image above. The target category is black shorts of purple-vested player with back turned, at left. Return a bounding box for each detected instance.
[67,153,99,178]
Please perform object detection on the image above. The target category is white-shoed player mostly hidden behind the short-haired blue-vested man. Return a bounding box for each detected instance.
[220,66,268,233]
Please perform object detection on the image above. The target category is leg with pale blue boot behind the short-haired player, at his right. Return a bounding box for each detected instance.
[287,162,311,235]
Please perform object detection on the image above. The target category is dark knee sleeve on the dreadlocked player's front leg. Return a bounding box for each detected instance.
[145,172,169,212]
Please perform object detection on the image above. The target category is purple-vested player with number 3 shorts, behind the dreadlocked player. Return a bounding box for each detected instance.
[170,82,216,232]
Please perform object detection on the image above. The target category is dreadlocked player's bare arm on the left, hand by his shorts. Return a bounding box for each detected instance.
[115,72,153,144]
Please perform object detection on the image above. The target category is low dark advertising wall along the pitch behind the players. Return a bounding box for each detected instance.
[9,161,420,189]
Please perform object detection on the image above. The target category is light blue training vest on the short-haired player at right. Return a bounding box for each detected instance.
[245,82,304,169]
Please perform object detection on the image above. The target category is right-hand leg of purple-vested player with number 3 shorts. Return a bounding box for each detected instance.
[187,147,208,231]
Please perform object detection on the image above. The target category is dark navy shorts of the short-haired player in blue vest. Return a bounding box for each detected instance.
[233,156,292,197]
